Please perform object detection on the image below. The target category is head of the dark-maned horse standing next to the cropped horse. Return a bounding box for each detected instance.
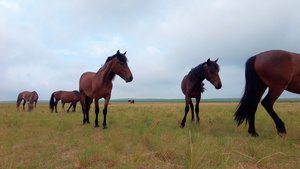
[203,58,222,89]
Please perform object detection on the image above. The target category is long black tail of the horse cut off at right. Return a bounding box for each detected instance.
[234,56,266,125]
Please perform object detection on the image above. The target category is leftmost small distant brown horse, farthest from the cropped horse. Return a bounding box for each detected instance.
[17,91,39,112]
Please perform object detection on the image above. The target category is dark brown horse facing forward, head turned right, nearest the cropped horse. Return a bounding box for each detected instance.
[180,59,222,128]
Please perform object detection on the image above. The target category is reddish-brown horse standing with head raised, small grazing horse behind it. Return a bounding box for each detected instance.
[79,51,133,129]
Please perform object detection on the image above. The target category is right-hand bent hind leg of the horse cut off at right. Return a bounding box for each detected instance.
[261,88,286,136]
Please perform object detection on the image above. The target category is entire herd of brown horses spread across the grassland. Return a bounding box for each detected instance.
[17,50,300,137]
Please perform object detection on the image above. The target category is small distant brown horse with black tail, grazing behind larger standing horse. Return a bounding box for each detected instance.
[49,90,80,113]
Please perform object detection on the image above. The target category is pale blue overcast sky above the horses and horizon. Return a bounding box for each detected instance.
[0,0,300,101]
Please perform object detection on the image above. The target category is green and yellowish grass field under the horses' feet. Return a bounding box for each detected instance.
[0,102,300,169]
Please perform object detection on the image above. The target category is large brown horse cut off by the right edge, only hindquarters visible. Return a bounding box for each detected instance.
[235,50,300,137]
